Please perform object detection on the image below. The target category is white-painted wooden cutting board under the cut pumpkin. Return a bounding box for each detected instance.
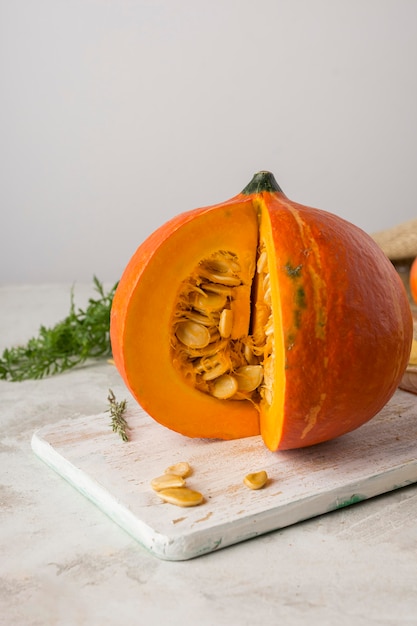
[32,390,417,560]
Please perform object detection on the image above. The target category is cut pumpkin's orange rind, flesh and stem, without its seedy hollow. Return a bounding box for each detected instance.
[111,172,412,451]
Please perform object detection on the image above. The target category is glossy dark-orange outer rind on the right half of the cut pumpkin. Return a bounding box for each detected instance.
[261,191,412,450]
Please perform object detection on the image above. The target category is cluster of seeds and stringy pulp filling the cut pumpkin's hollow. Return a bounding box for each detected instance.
[173,245,274,403]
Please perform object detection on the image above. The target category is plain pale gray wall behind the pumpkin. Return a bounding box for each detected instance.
[0,0,417,284]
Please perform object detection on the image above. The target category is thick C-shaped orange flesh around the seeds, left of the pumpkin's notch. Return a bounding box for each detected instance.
[111,199,259,439]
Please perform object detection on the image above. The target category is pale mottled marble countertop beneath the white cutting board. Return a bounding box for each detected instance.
[0,285,417,626]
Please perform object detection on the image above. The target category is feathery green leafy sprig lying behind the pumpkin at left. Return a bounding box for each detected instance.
[0,276,117,381]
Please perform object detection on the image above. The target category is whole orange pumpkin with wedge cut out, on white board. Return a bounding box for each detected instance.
[110,171,412,451]
